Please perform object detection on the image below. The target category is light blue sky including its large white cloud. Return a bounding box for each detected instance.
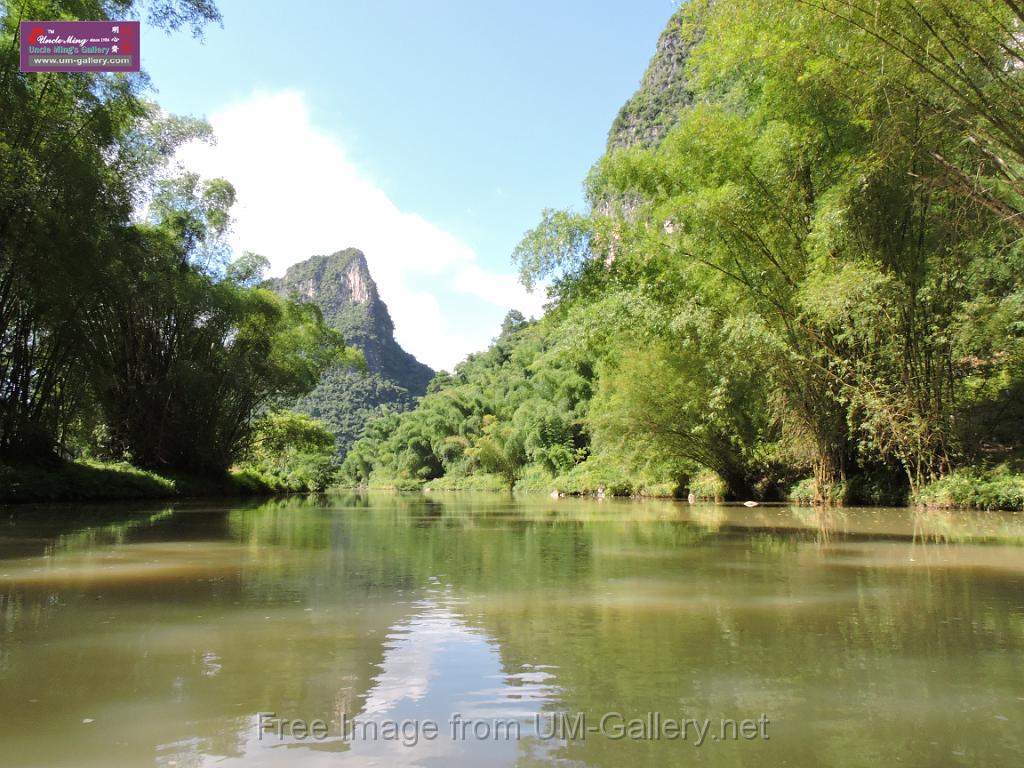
[140,0,677,370]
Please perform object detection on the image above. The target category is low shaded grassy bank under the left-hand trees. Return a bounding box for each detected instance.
[0,461,304,503]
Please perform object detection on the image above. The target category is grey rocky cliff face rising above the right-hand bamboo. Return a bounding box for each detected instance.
[608,0,714,152]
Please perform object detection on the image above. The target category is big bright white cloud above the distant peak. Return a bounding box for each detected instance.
[178,91,544,370]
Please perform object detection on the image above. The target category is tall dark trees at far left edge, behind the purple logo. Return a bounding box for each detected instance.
[0,0,226,460]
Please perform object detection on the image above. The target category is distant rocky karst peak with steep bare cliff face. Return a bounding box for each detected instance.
[267,248,434,456]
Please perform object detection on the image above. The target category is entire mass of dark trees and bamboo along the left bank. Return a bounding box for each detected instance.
[0,0,362,497]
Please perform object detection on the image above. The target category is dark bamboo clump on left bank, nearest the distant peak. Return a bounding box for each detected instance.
[83,210,342,472]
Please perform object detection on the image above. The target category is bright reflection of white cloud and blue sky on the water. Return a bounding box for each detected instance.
[149,591,556,766]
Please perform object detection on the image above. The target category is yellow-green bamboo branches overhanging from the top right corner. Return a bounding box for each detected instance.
[794,0,1024,230]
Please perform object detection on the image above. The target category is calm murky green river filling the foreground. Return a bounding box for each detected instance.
[0,494,1024,768]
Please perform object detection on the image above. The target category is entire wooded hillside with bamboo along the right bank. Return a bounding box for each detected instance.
[342,0,1024,509]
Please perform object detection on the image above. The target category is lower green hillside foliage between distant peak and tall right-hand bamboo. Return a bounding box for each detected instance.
[341,312,593,487]
